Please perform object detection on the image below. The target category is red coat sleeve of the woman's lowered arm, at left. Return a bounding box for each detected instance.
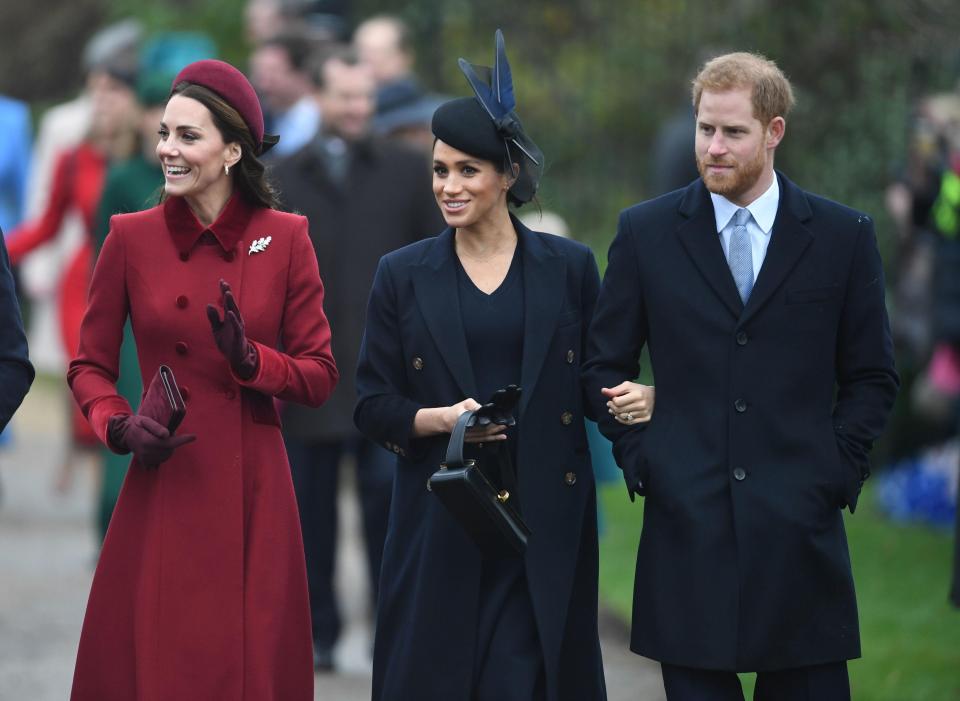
[67,218,133,452]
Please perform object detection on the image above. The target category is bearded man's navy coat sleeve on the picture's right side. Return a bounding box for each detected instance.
[833,216,900,512]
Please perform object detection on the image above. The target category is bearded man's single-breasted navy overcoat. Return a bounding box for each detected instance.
[584,174,898,671]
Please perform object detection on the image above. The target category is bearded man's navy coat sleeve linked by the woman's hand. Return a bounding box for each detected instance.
[583,212,647,500]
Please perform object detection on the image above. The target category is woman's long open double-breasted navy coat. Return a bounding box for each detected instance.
[354,219,606,701]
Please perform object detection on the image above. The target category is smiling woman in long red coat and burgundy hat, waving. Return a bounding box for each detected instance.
[68,60,337,701]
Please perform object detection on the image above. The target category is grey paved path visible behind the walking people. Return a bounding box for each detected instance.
[0,380,663,701]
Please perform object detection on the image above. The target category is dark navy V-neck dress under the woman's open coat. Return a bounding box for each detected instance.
[457,245,544,701]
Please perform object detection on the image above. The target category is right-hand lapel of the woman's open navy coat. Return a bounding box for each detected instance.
[513,218,567,415]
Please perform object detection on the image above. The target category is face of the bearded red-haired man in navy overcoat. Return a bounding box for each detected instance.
[696,88,785,206]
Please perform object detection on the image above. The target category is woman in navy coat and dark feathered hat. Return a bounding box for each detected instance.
[355,33,641,701]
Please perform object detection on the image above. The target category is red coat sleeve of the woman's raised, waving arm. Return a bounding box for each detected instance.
[233,218,339,407]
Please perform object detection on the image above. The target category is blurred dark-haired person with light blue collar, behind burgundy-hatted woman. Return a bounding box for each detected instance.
[250,30,320,159]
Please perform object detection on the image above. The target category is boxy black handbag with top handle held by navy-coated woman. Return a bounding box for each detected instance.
[429,411,530,556]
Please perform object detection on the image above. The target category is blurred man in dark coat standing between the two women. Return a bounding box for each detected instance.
[273,48,443,669]
